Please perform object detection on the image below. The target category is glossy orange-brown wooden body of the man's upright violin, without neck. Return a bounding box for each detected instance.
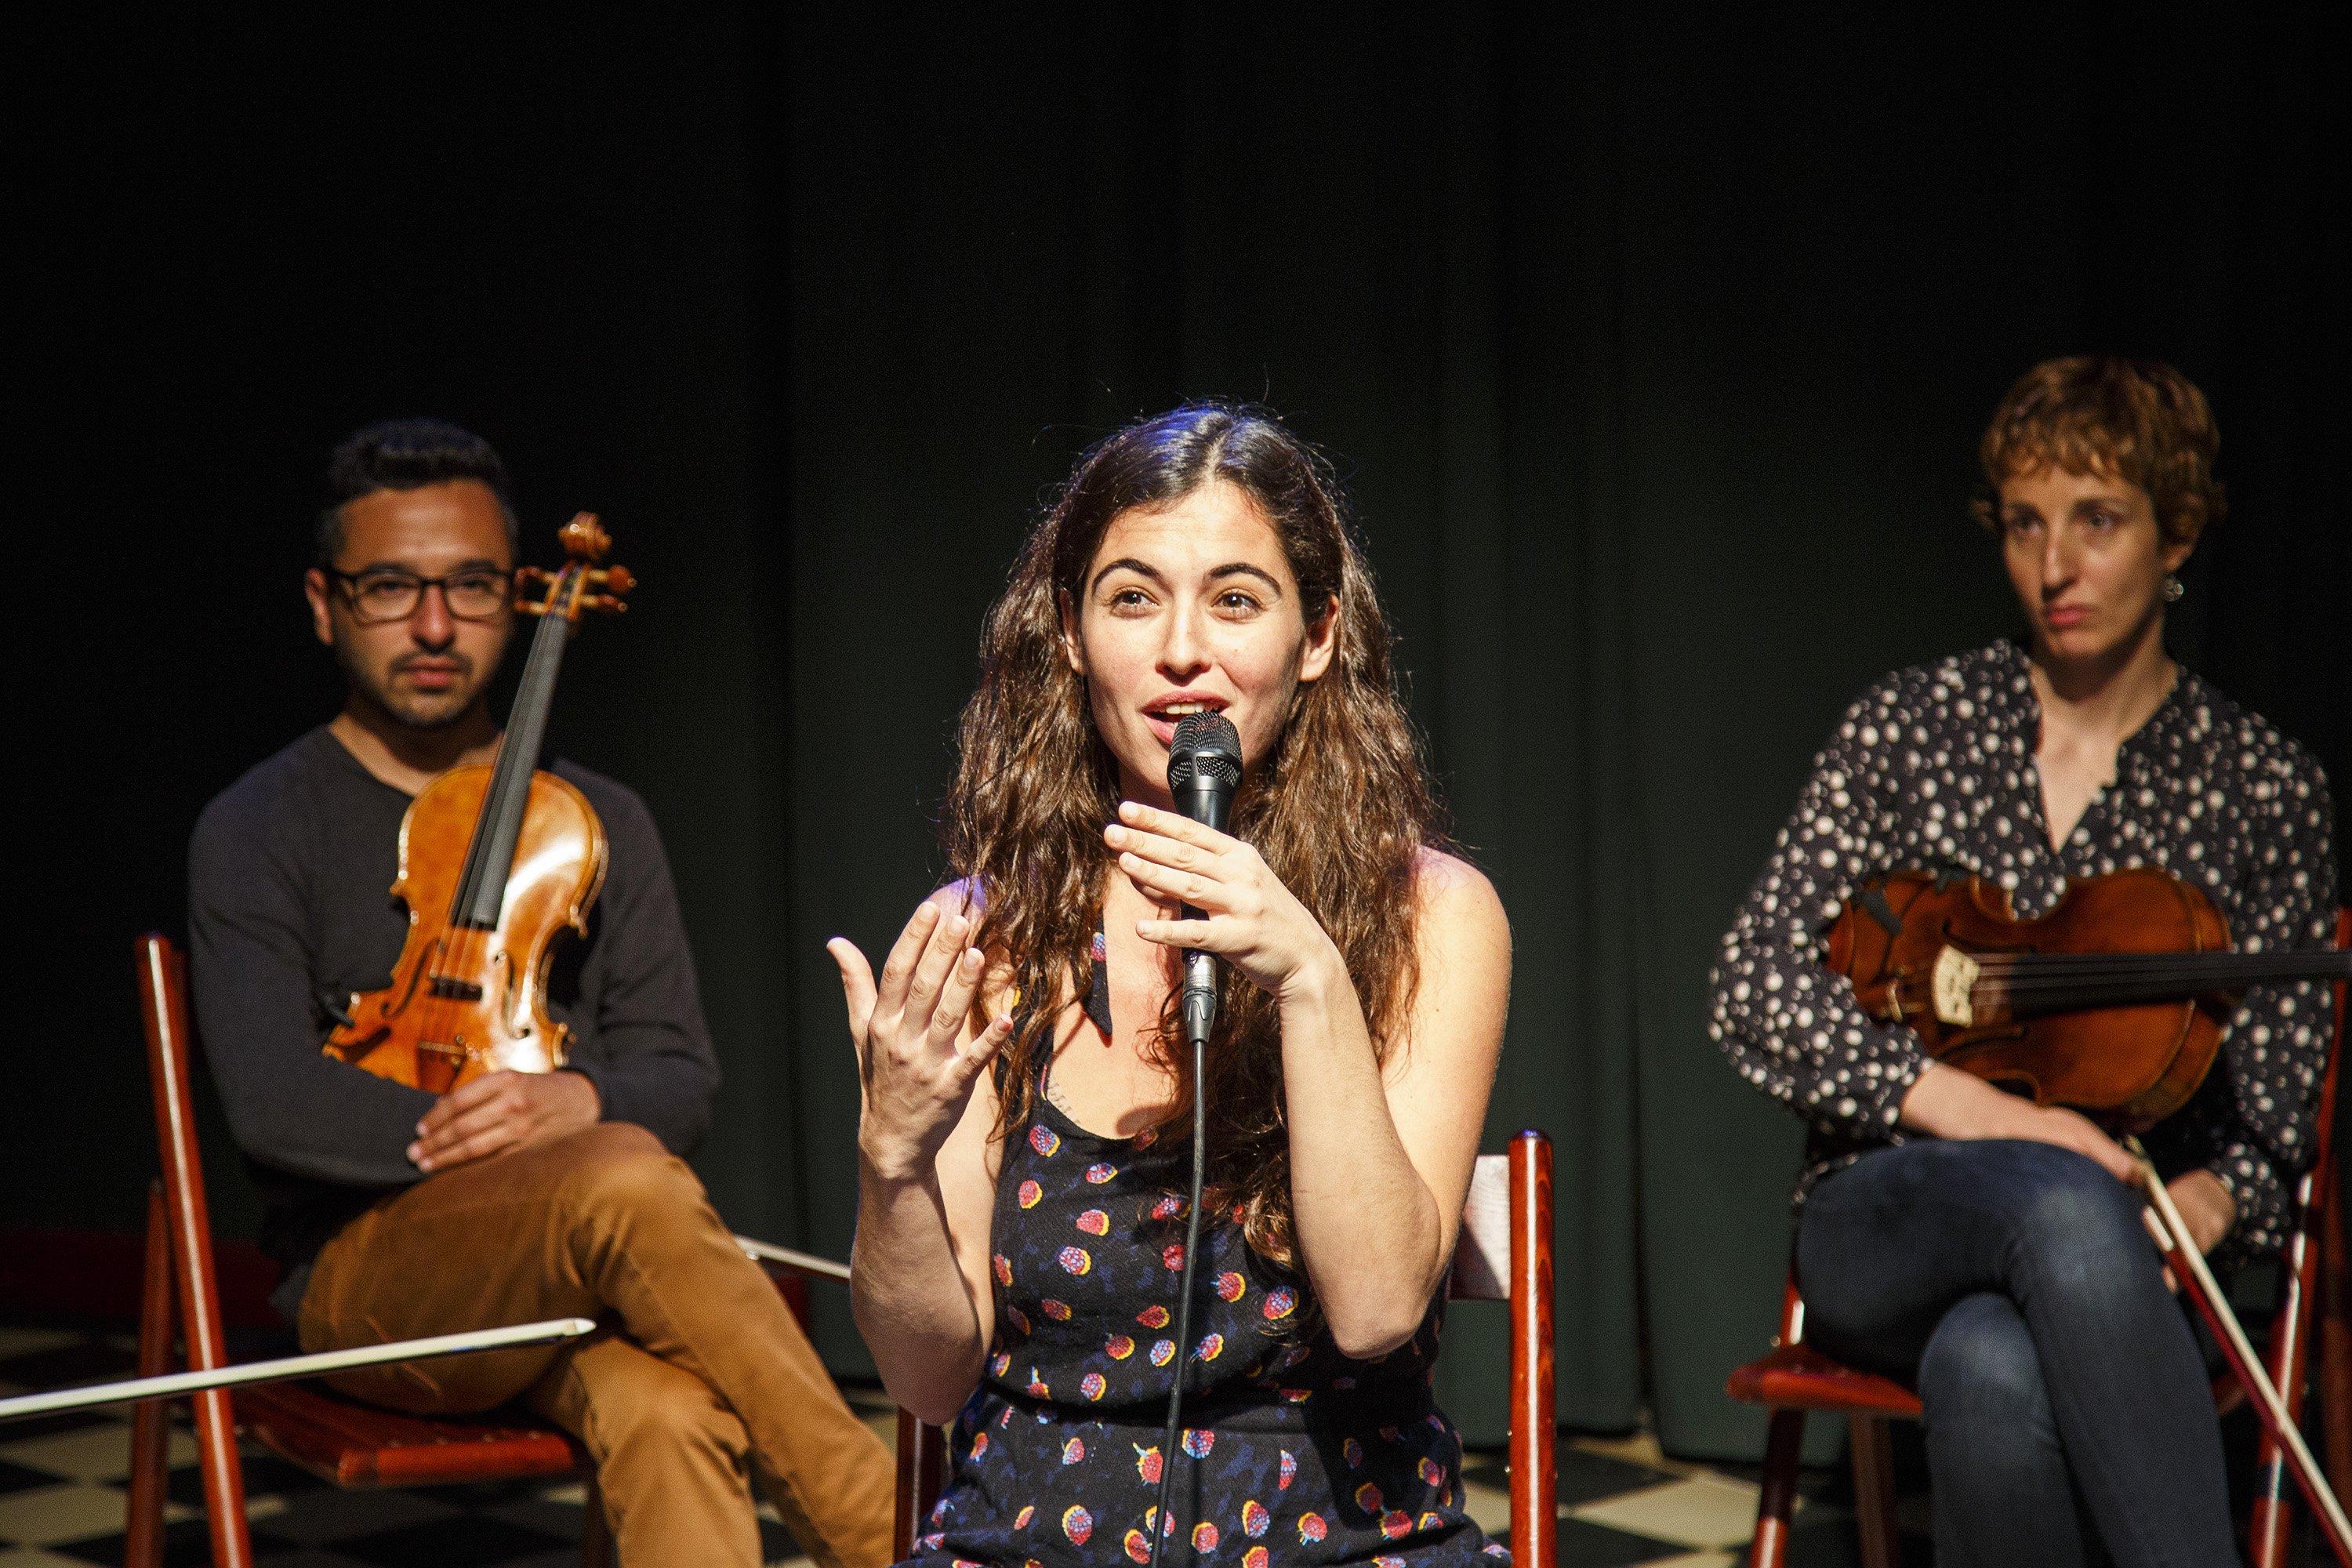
[327,767,612,1093]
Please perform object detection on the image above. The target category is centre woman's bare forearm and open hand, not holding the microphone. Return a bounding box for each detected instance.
[828,891,1007,1427]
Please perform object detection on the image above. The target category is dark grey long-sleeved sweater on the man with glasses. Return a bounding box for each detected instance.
[188,729,720,1305]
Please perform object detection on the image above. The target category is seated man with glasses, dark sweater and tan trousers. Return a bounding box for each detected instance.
[188,421,891,1568]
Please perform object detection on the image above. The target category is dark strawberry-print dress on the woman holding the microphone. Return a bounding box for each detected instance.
[910,1053,1510,1568]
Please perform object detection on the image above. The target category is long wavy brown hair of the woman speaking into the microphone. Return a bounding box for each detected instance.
[941,405,1451,1267]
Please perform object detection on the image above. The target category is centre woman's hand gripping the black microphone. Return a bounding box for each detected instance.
[1103,799,1338,996]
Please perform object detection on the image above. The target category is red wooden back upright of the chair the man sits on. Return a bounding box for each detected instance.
[134,931,252,1563]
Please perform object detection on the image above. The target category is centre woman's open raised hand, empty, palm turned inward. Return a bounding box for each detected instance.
[826,900,1011,1178]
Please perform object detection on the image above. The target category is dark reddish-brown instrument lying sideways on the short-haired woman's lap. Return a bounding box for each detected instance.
[1828,867,2352,1133]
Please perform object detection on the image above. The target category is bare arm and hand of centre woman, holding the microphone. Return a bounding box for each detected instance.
[1105,801,1510,1356]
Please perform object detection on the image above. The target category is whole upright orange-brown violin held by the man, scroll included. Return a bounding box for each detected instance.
[322,513,635,1095]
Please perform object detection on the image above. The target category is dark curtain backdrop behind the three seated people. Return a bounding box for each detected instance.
[0,0,2352,1455]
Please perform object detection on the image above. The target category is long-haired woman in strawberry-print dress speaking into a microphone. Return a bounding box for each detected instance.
[833,407,1510,1568]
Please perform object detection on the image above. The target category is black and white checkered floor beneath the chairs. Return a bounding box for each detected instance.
[0,1328,1926,1568]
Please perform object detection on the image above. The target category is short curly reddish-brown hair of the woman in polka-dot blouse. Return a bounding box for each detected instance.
[1969,355,2225,546]
